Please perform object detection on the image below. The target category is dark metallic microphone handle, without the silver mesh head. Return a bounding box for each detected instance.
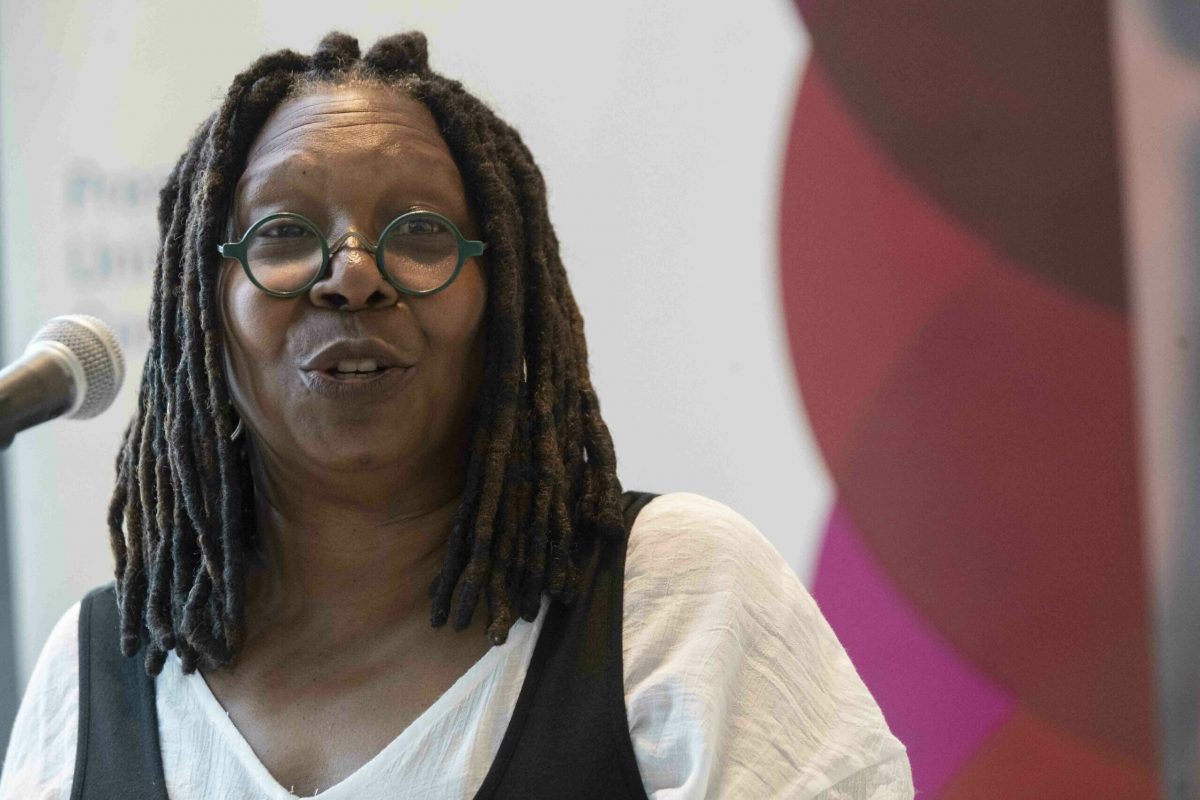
[0,349,76,450]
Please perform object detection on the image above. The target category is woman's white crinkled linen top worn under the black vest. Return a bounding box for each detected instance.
[0,493,913,800]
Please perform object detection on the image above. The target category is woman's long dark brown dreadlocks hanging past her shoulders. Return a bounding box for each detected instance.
[108,32,623,675]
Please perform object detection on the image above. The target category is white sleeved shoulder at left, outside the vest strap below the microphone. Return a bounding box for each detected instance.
[0,602,80,800]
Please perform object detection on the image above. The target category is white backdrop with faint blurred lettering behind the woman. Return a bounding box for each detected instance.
[0,0,830,686]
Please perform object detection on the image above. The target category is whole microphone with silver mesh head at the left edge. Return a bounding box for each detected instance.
[0,314,125,450]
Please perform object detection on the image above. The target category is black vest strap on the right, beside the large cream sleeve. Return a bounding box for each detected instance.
[475,492,655,800]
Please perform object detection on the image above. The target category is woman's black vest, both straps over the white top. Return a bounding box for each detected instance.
[71,492,654,800]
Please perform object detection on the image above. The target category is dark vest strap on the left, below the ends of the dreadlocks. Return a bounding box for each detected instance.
[71,583,167,800]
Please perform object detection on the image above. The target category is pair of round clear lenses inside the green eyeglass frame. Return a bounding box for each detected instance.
[246,213,458,293]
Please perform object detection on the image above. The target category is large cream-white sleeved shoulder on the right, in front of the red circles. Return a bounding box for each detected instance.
[622,493,911,799]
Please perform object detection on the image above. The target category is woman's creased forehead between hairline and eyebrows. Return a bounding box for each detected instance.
[236,86,462,212]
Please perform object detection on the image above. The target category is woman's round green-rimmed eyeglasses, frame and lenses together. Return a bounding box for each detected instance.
[217,211,487,297]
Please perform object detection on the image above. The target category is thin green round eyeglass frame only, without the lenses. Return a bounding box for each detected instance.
[217,211,487,297]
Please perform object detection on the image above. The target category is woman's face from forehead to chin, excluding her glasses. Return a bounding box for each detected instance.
[221,86,487,482]
